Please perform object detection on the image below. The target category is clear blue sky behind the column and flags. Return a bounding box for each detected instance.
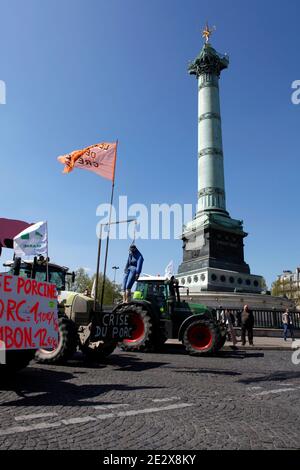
[0,0,300,285]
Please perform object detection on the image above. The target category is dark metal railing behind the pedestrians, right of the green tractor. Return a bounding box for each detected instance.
[217,308,300,330]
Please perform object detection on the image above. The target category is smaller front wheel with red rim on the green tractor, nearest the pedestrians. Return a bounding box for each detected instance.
[182,320,219,356]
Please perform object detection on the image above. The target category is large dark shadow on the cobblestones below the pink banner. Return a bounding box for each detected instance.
[0,367,164,407]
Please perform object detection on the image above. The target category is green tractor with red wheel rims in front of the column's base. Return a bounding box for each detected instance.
[119,276,226,356]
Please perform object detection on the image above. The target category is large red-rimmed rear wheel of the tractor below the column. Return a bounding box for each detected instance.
[121,304,155,352]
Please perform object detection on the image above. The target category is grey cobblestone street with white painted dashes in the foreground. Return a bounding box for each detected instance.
[0,345,300,450]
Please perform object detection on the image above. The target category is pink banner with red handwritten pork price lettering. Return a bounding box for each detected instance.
[0,273,58,351]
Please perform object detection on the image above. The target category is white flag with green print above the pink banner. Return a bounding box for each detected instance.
[14,222,48,261]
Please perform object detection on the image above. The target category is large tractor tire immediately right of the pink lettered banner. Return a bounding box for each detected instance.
[35,317,78,364]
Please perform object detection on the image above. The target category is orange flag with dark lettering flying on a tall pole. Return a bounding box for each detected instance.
[57,142,117,181]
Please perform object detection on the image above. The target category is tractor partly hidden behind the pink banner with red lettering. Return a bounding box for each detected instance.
[4,257,126,364]
